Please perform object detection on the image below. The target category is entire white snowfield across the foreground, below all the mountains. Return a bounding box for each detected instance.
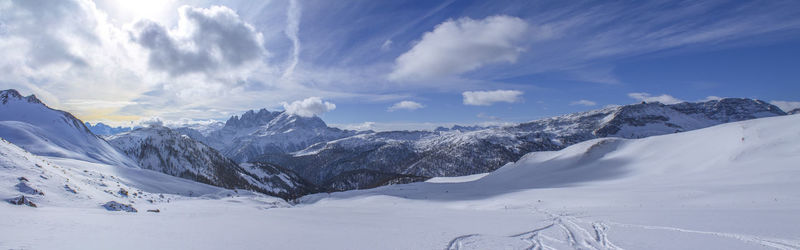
[0,115,800,249]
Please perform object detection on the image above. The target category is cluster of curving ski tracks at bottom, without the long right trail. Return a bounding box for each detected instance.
[446,215,622,250]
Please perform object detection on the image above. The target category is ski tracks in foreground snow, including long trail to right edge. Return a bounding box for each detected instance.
[445,209,800,250]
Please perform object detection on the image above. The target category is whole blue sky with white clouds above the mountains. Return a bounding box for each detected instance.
[0,0,800,129]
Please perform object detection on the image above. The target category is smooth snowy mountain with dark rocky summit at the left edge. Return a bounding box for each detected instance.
[0,89,136,167]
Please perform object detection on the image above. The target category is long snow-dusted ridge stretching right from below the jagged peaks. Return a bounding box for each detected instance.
[266,98,785,186]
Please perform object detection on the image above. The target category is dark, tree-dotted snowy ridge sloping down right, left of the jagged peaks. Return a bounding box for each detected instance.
[108,125,313,198]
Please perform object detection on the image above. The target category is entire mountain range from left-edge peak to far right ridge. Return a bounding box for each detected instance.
[0,90,787,199]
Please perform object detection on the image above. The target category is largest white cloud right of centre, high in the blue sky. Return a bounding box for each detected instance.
[389,16,528,80]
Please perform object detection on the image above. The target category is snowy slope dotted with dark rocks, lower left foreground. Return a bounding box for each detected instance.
[0,139,276,209]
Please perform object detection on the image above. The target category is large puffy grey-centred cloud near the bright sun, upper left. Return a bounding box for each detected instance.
[133,6,267,75]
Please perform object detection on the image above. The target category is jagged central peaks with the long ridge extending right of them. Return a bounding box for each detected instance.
[180,98,786,190]
